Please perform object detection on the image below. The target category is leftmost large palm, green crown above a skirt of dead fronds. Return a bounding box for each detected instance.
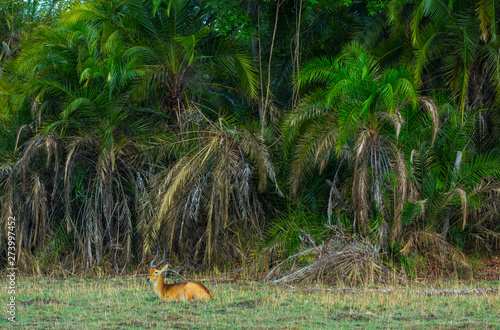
[2,24,145,267]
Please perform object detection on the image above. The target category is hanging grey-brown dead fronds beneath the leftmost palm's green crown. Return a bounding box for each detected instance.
[0,124,139,273]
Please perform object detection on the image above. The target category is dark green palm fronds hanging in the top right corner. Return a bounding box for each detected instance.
[381,0,500,124]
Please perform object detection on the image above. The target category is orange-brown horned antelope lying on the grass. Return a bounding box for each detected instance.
[146,249,212,301]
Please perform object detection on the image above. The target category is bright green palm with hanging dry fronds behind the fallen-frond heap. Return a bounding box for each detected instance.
[285,43,418,240]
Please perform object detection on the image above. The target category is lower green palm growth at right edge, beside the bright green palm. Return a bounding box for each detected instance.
[399,103,500,254]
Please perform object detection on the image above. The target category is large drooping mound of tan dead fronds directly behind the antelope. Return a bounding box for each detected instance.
[139,114,281,265]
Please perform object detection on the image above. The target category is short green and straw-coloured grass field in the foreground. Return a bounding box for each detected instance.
[0,278,500,329]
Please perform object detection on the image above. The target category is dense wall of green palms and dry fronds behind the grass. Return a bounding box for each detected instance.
[0,0,500,274]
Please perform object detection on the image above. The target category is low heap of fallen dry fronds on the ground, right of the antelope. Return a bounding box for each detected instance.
[264,232,402,285]
